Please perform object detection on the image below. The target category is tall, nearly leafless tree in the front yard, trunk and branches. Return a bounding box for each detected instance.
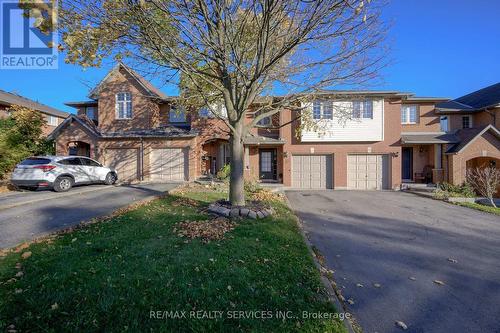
[25,0,385,205]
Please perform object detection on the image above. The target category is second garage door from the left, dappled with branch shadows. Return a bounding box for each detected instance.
[150,148,188,181]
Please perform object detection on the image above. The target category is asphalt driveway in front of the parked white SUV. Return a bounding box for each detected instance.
[0,183,179,248]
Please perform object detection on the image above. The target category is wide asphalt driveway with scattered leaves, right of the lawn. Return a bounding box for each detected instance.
[286,191,500,333]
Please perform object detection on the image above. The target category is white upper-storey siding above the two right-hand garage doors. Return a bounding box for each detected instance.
[302,99,384,142]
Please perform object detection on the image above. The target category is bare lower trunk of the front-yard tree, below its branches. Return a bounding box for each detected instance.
[229,127,245,206]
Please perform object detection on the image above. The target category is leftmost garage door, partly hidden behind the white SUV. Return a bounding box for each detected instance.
[104,148,139,183]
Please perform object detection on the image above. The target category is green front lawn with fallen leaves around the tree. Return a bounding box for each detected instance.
[0,185,345,332]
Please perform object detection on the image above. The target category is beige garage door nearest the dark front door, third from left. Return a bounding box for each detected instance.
[292,155,333,189]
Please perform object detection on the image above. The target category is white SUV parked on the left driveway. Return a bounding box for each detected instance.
[12,156,118,192]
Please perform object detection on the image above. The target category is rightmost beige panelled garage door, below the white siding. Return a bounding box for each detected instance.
[347,155,389,190]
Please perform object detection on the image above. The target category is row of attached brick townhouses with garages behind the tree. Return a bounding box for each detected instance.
[51,63,500,190]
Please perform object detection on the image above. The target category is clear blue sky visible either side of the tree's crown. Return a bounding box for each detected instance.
[0,0,500,111]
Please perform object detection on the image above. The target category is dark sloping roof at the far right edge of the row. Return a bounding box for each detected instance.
[436,82,500,111]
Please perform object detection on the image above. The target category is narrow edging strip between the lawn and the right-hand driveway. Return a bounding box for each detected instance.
[284,193,360,333]
